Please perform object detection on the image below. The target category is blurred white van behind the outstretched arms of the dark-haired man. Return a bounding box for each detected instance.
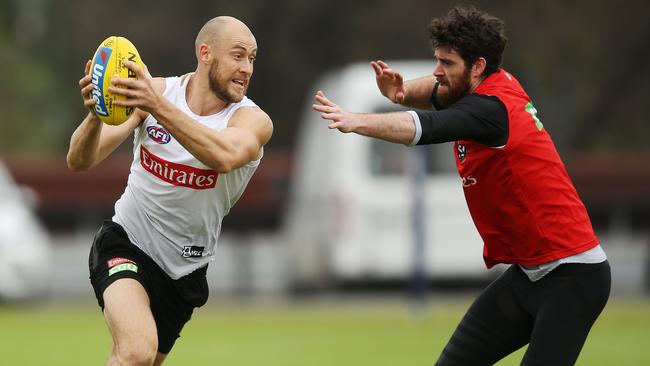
[285,60,494,287]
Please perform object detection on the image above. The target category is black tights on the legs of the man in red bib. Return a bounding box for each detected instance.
[436,261,611,366]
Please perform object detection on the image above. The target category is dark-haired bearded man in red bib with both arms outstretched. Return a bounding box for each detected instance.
[313,7,611,366]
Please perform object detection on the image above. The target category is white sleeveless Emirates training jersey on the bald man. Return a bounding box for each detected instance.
[113,77,260,279]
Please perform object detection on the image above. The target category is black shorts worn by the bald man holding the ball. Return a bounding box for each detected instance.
[88,220,208,354]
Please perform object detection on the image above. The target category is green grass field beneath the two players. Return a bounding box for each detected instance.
[0,298,650,366]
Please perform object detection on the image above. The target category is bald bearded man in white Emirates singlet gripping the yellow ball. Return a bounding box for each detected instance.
[67,17,273,365]
